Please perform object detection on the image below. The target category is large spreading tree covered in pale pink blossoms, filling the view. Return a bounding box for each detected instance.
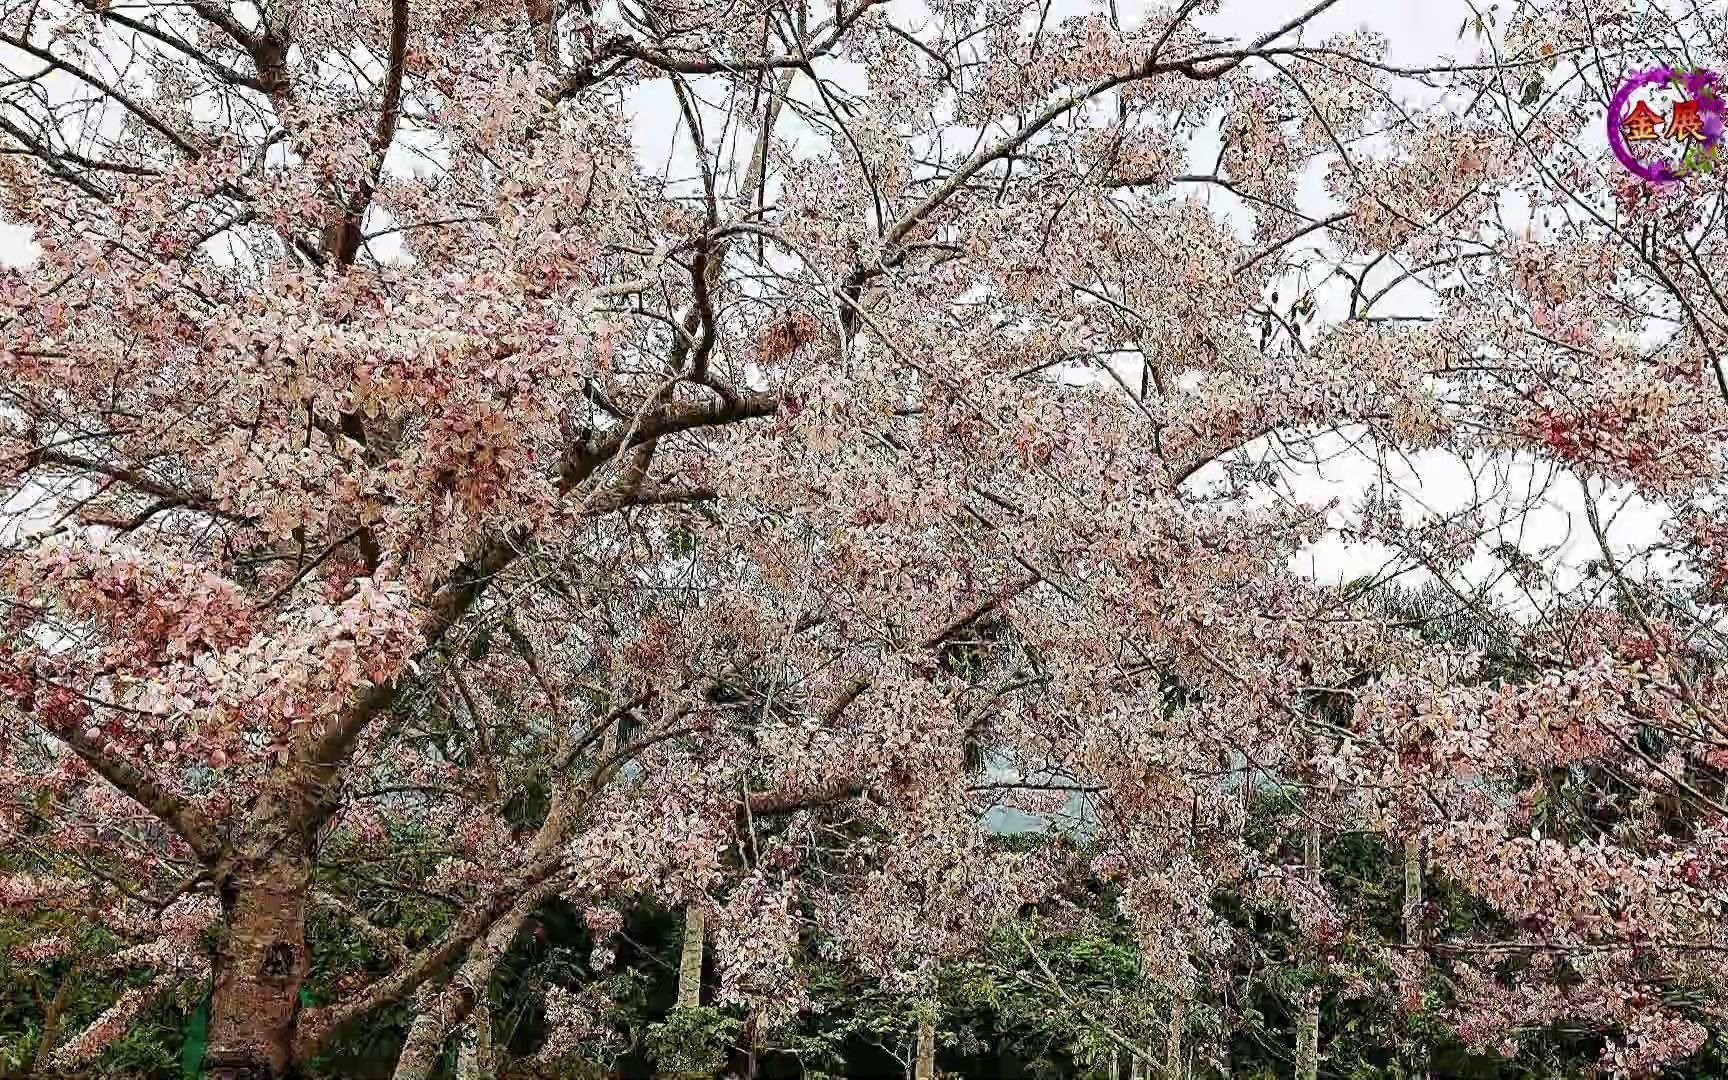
[0,0,1728,1077]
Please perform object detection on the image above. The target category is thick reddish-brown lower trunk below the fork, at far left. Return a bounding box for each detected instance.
[204,838,311,1080]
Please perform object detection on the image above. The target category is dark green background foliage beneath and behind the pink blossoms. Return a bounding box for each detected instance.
[0,667,1728,1080]
